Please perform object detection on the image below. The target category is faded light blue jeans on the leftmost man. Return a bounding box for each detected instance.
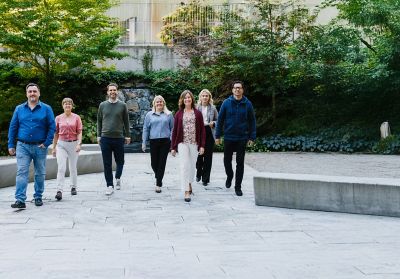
[15,142,47,202]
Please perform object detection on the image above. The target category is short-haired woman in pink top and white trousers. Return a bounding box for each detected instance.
[53,98,82,201]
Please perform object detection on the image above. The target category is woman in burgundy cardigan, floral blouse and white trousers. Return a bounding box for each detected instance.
[171,90,206,202]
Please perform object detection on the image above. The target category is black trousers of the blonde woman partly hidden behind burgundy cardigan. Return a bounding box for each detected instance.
[196,126,214,183]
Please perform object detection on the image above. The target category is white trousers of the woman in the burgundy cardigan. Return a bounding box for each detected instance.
[178,143,199,191]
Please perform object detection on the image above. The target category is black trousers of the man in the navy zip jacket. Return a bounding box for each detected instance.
[224,140,247,188]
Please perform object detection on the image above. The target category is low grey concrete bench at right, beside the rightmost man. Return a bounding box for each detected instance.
[254,173,400,217]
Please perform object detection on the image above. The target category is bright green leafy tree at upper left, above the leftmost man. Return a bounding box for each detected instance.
[0,0,123,99]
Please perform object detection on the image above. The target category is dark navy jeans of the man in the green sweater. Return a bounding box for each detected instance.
[100,137,125,187]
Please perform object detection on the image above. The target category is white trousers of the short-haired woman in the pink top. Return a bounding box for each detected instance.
[56,140,79,192]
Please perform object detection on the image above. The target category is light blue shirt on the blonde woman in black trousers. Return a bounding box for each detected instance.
[142,111,174,144]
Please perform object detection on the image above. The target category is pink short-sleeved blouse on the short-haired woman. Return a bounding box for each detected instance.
[56,113,82,141]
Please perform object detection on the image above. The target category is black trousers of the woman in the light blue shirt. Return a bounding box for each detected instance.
[150,138,171,187]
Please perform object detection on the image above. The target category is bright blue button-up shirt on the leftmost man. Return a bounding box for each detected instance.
[8,101,56,148]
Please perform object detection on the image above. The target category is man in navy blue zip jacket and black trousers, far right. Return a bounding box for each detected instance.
[215,81,256,196]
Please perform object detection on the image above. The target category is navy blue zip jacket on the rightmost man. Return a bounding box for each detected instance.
[215,96,256,141]
